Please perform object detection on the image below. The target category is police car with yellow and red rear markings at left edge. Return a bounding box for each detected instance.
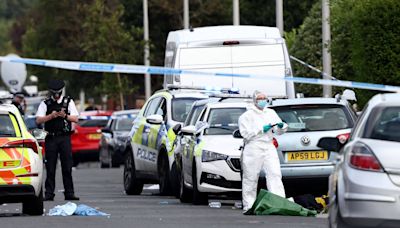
[0,105,45,215]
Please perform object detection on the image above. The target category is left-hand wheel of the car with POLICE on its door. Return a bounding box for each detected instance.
[124,152,143,195]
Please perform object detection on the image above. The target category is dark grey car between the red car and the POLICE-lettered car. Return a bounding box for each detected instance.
[99,109,140,168]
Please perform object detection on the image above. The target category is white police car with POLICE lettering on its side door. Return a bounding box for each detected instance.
[124,89,208,195]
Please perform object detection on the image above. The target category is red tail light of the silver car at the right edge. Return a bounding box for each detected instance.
[350,143,382,171]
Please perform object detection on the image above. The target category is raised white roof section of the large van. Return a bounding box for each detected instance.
[168,25,282,43]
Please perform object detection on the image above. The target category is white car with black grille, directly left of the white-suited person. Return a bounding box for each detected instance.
[175,100,248,204]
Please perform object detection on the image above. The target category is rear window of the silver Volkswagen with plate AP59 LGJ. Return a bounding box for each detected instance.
[273,104,353,132]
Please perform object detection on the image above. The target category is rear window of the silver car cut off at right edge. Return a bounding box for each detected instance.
[363,107,400,142]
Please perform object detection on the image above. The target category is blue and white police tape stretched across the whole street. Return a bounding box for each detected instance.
[0,56,400,92]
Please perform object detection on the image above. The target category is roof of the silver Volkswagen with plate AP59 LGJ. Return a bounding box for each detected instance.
[271,97,347,107]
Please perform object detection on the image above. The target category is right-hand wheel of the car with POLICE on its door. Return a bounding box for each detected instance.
[158,151,172,196]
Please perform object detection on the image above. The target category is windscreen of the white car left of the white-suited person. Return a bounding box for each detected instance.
[204,108,246,135]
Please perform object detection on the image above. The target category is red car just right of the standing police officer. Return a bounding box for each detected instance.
[71,111,113,166]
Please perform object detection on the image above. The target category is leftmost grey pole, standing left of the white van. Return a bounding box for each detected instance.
[143,0,151,99]
